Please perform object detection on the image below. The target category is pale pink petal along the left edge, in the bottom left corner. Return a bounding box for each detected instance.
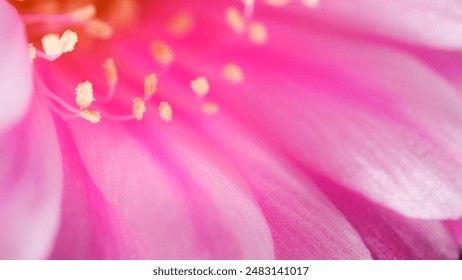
[0,95,62,259]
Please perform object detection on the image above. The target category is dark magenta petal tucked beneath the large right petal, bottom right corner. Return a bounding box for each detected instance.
[316,177,459,260]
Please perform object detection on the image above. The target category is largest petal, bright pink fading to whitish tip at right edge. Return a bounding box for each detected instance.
[168,15,462,219]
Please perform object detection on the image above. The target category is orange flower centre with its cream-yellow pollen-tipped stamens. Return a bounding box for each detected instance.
[9,0,319,123]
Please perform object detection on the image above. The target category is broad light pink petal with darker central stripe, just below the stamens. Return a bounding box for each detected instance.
[70,117,274,259]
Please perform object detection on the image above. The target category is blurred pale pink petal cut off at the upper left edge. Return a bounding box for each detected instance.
[0,1,32,132]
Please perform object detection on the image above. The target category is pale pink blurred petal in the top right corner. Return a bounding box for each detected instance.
[293,0,462,50]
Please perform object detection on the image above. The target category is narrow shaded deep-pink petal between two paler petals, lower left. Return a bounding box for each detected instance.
[50,123,143,259]
